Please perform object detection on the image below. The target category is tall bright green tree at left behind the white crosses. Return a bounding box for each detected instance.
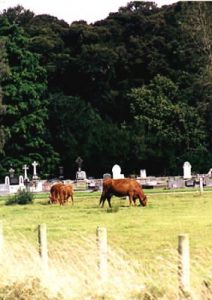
[0,17,59,174]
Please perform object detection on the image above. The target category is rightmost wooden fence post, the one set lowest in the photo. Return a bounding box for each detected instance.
[178,234,190,296]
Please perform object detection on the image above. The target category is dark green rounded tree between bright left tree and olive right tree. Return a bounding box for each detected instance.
[49,94,130,176]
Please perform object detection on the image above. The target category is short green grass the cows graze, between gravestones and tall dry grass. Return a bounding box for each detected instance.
[0,190,212,259]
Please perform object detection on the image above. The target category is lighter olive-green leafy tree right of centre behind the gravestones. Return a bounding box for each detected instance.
[129,75,207,173]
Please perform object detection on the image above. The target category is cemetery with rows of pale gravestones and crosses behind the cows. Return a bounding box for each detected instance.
[0,157,212,196]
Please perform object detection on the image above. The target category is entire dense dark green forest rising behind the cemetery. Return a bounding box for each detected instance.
[0,1,212,178]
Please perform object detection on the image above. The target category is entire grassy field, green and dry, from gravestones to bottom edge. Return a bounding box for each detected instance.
[0,191,212,300]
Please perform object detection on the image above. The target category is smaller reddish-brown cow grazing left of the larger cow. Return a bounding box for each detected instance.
[50,183,74,205]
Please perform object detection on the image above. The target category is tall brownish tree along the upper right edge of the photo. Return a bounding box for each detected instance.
[182,1,212,150]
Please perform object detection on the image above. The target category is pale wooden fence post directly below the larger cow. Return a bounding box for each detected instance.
[96,226,108,282]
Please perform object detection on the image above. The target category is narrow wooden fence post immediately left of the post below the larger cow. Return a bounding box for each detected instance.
[38,224,48,272]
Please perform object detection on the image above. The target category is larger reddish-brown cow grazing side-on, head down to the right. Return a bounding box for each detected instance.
[99,178,147,207]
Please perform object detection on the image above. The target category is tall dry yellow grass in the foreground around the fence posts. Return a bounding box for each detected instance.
[0,236,212,300]
